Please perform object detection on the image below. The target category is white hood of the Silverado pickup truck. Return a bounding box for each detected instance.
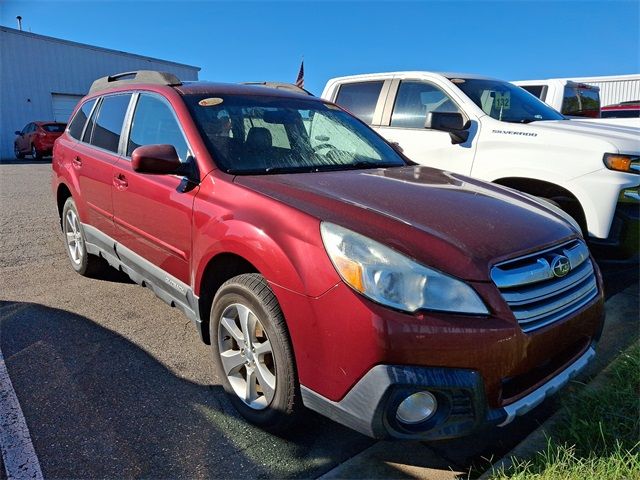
[528,120,640,153]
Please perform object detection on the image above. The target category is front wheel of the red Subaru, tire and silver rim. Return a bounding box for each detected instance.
[209,273,301,432]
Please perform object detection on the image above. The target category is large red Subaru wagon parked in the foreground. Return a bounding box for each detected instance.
[52,72,604,440]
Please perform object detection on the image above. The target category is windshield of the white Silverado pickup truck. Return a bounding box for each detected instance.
[449,78,564,123]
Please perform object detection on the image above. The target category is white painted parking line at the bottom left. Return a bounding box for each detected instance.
[0,349,44,480]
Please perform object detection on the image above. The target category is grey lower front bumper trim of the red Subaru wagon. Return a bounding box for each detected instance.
[301,343,595,440]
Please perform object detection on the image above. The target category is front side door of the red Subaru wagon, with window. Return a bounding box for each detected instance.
[113,93,198,284]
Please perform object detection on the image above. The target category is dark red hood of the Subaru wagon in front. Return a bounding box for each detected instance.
[234,166,577,281]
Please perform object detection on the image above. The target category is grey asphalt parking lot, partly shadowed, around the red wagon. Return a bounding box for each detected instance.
[0,161,637,478]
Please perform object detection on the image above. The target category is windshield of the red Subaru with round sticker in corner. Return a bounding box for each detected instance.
[185,94,405,174]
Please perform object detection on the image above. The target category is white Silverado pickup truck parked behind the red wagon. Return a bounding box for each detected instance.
[322,71,640,261]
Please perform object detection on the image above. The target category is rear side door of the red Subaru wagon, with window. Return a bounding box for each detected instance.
[70,93,131,241]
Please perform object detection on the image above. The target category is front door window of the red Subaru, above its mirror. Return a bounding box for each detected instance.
[127,94,191,162]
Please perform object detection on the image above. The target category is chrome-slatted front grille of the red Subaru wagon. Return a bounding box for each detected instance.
[491,240,598,332]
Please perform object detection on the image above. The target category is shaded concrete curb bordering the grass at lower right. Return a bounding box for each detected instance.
[478,283,640,480]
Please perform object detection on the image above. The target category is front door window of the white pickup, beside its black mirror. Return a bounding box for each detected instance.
[391,81,460,128]
